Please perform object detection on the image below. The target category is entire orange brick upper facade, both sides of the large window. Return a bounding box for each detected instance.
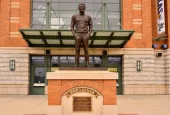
[0,0,170,48]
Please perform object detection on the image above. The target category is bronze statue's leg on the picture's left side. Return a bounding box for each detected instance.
[75,34,81,67]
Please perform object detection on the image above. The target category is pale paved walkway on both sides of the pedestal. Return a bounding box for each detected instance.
[0,95,170,115]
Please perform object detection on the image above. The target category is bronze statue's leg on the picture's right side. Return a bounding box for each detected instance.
[82,35,89,67]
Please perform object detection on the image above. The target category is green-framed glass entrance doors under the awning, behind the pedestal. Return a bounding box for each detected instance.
[30,55,123,95]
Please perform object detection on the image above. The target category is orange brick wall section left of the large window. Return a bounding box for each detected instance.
[0,0,31,47]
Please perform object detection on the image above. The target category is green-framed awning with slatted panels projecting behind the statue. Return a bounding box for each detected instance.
[20,29,134,48]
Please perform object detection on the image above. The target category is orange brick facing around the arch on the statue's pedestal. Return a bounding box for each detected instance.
[48,80,116,105]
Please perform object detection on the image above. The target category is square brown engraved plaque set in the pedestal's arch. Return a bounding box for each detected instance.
[73,97,91,111]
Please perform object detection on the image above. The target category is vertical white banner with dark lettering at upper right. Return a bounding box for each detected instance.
[157,0,165,34]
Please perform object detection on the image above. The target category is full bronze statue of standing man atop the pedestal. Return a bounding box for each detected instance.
[71,3,93,67]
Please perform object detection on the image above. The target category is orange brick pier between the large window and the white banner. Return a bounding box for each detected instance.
[122,0,152,48]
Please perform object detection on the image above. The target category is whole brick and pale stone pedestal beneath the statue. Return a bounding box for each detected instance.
[47,68,118,115]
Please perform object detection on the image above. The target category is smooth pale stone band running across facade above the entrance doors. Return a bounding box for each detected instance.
[0,47,154,55]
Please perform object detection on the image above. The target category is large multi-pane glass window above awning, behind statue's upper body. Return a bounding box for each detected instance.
[32,0,121,30]
